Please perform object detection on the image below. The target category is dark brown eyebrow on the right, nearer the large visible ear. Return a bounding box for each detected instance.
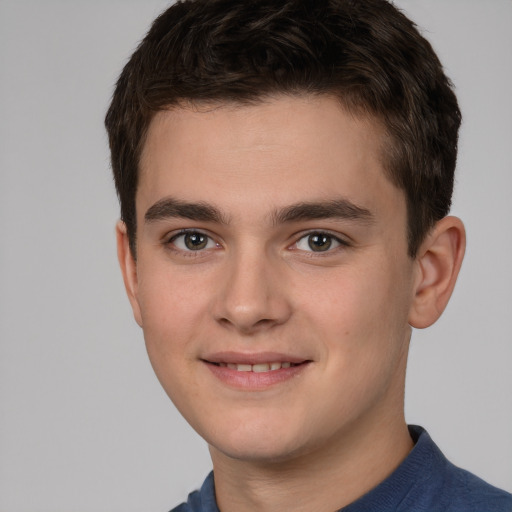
[272,198,375,224]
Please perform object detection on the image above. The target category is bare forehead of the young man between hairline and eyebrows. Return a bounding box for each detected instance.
[137,96,402,222]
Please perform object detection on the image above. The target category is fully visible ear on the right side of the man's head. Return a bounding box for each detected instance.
[409,217,466,329]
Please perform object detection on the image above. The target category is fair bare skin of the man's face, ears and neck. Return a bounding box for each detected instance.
[117,96,464,512]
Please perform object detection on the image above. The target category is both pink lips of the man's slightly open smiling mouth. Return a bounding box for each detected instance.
[201,352,312,391]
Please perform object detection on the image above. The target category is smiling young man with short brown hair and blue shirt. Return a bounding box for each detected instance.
[106,0,512,512]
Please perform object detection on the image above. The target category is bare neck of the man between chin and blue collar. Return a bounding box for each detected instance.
[210,415,413,512]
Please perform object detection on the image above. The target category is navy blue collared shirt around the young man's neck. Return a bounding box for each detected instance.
[171,426,512,512]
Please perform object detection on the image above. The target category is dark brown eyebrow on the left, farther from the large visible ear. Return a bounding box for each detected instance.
[144,197,228,224]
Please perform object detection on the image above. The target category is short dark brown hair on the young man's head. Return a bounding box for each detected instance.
[105,0,461,257]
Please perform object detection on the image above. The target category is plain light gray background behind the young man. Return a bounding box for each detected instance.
[0,0,512,512]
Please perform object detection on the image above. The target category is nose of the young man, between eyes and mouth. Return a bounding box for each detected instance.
[215,251,292,335]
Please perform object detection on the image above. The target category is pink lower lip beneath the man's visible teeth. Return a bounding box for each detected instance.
[205,362,309,391]
